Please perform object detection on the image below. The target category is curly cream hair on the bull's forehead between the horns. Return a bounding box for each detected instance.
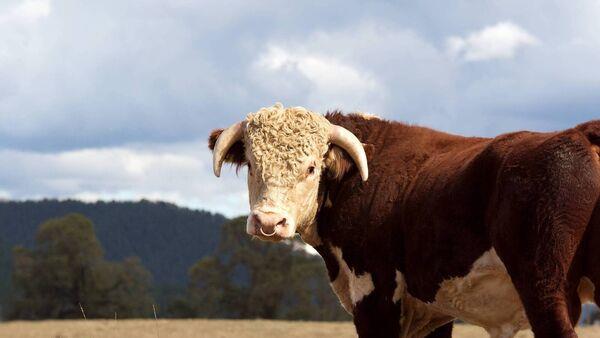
[245,103,331,185]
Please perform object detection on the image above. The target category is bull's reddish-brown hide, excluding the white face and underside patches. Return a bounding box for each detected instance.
[210,112,600,337]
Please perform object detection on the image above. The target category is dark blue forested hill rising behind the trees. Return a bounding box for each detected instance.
[0,200,226,286]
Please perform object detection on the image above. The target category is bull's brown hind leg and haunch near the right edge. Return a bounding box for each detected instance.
[488,133,600,337]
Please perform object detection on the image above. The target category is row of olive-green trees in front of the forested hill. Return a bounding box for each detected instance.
[4,214,349,320]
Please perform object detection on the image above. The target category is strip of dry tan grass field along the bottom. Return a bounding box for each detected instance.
[0,319,600,338]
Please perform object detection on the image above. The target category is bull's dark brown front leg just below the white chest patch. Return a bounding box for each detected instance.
[353,291,401,338]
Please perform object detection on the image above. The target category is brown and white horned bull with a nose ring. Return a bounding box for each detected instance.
[209,104,600,337]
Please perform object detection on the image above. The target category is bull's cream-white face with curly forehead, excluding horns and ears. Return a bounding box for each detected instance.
[244,107,330,240]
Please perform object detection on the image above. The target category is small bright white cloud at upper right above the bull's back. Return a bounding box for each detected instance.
[446,22,539,61]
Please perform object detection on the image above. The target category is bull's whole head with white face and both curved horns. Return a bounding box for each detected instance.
[211,104,368,241]
